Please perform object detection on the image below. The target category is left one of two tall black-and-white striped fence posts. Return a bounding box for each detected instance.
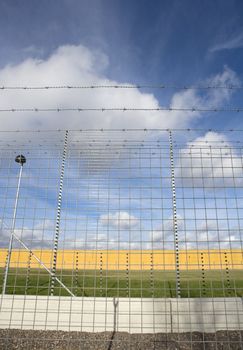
[51,130,68,296]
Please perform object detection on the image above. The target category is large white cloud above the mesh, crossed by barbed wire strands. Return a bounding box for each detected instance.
[0,45,238,130]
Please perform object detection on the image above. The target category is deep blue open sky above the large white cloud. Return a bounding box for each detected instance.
[0,0,243,83]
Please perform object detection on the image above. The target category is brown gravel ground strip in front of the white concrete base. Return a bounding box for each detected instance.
[0,329,243,350]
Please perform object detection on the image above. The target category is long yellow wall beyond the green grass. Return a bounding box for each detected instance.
[0,249,243,270]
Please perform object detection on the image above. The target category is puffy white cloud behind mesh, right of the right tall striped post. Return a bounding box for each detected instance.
[176,132,243,187]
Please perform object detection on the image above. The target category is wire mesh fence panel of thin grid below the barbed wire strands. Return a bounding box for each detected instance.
[0,130,243,349]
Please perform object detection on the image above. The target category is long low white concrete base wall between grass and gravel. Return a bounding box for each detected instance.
[0,295,243,333]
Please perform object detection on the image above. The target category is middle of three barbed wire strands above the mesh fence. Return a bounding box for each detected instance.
[0,107,243,113]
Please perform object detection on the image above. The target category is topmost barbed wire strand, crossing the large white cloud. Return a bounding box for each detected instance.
[0,84,243,90]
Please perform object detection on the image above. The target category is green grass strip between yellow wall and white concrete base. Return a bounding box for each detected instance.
[0,268,243,298]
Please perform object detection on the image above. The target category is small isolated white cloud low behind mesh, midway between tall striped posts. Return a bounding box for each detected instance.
[99,211,139,230]
